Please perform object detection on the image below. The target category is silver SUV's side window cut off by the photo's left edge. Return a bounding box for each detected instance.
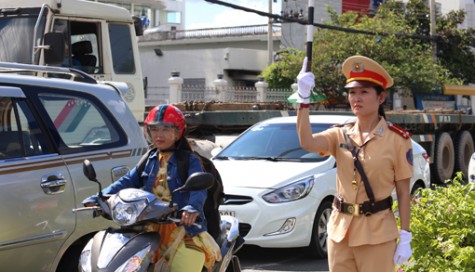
[0,97,51,160]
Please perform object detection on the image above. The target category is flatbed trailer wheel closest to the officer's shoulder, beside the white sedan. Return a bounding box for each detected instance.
[431,132,455,184]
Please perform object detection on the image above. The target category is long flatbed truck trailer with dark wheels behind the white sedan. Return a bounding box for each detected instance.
[176,85,475,184]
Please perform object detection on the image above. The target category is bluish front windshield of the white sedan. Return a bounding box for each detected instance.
[215,124,330,162]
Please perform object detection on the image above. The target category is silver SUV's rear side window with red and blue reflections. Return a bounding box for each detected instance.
[38,93,125,153]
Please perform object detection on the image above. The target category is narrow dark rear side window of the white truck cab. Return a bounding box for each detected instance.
[109,23,135,74]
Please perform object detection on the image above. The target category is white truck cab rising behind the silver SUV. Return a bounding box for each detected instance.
[0,0,145,122]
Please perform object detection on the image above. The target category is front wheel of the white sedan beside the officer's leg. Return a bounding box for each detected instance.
[308,200,332,259]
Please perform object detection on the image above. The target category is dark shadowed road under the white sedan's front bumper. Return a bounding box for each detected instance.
[238,246,328,272]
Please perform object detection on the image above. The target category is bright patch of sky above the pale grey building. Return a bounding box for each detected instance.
[185,0,281,29]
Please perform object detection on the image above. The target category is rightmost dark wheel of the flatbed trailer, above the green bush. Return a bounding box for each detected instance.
[455,130,475,179]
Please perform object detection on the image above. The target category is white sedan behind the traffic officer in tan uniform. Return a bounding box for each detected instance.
[213,115,430,258]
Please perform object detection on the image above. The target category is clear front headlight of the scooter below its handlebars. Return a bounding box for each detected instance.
[111,197,147,226]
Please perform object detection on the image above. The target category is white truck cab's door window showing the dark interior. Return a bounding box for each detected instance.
[53,19,103,74]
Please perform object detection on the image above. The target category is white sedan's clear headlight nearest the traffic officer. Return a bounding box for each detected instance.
[262,176,314,203]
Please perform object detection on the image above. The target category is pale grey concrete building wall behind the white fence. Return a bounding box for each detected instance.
[139,30,280,88]
